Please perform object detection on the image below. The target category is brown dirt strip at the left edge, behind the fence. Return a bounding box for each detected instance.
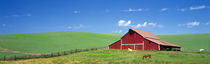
[0,47,42,55]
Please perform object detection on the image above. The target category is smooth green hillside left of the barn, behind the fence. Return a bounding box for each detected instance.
[0,32,121,53]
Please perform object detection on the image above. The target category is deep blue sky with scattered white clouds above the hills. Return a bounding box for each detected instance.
[0,0,210,34]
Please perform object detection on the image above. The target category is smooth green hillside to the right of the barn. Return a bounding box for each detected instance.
[158,33,210,51]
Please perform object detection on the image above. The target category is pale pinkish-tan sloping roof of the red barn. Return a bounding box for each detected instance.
[130,29,179,47]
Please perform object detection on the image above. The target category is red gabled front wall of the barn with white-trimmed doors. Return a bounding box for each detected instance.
[109,30,159,50]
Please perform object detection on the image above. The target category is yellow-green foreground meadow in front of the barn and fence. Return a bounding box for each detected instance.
[0,49,210,64]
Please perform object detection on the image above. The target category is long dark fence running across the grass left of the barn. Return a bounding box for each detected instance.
[0,48,105,61]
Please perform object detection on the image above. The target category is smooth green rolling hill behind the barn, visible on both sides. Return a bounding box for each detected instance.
[0,32,210,56]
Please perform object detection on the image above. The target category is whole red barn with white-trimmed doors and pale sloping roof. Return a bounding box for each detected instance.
[109,29,181,51]
